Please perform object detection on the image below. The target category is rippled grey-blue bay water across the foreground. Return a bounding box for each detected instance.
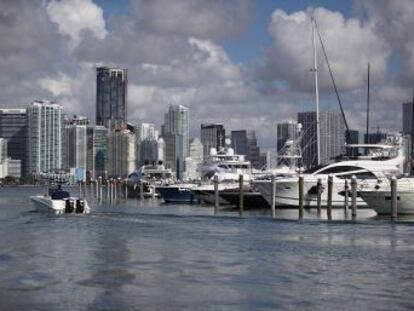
[0,188,414,310]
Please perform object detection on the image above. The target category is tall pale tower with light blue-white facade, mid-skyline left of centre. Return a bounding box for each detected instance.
[162,105,189,179]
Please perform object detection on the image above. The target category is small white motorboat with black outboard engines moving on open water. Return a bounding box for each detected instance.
[30,191,90,214]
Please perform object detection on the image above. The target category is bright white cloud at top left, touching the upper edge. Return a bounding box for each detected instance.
[46,0,107,48]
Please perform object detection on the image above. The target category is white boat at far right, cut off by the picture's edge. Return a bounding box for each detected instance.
[358,177,414,215]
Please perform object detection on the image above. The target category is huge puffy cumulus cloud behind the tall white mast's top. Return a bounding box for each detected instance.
[260,8,390,92]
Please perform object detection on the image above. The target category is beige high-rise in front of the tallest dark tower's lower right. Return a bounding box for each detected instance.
[108,129,136,178]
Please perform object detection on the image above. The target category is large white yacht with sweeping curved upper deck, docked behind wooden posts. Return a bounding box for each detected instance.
[253,137,406,207]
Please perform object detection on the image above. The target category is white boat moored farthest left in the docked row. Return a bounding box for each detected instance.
[125,164,173,198]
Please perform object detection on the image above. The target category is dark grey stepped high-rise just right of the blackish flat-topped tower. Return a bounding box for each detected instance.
[231,130,260,168]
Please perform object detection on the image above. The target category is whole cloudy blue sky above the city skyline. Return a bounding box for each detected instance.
[0,0,414,148]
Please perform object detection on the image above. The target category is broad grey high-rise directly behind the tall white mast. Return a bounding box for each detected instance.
[298,111,345,167]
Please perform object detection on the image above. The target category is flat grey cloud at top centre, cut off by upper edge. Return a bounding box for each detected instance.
[131,0,253,38]
